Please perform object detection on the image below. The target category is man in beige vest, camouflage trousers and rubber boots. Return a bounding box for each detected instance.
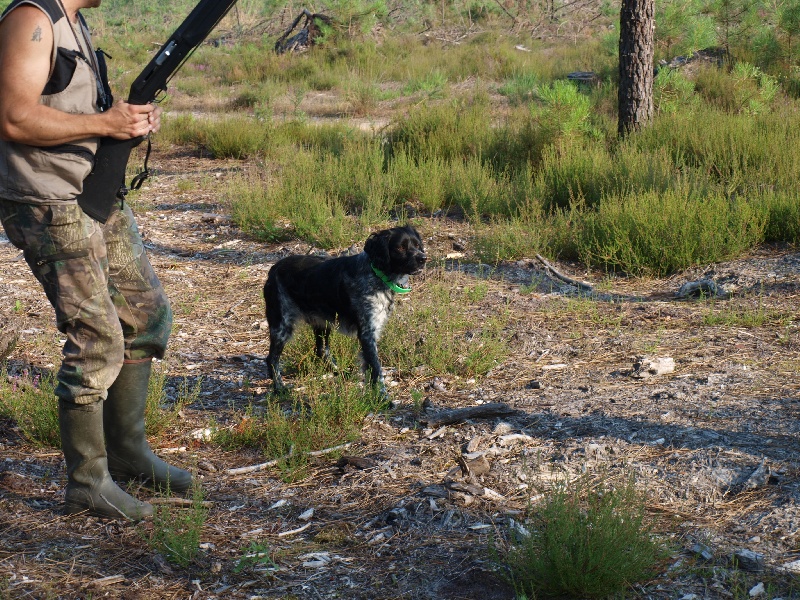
[0,0,192,520]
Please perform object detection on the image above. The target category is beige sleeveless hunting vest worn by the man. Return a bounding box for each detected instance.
[0,0,99,204]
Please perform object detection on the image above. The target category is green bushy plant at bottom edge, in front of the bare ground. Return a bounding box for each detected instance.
[502,477,665,598]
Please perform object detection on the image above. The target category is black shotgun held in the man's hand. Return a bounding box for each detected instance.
[77,0,241,223]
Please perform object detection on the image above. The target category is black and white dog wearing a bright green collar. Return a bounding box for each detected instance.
[264,226,427,395]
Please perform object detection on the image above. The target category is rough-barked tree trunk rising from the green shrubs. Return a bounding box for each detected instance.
[617,0,655,137]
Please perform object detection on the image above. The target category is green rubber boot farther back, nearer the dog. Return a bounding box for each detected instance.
[103,360,192,494]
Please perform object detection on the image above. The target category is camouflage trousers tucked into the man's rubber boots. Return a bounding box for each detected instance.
[0,199,172,404]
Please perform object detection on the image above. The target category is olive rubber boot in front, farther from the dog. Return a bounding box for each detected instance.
[58,400,153,521]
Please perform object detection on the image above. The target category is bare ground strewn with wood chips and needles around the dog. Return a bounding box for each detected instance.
[0,149,800,600]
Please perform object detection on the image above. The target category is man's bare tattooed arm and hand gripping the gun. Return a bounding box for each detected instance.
[0,5,161,146]
